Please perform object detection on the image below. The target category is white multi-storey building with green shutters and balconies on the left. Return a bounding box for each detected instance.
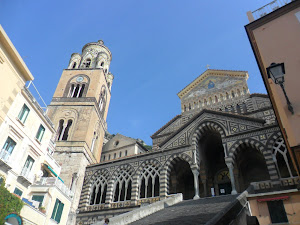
[0,24,73,225]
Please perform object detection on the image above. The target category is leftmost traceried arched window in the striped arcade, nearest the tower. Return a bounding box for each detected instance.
[90,175,107,205]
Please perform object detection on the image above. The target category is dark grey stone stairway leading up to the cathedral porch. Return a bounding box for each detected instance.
[131,195,237,225]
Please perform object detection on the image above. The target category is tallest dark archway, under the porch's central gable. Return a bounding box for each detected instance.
[198,130,231,197]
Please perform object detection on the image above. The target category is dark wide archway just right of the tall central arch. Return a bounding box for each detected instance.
[235,146,270,192]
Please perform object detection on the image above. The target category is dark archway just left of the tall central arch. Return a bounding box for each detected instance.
[169,158,195,200]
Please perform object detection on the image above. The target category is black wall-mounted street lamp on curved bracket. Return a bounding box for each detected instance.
[267,63,294,114]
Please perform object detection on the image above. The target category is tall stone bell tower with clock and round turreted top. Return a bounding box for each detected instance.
[47,40,114,224]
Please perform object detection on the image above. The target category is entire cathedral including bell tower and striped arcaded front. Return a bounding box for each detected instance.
[47,41,294,224]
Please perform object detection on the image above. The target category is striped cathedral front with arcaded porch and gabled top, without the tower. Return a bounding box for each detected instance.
[77,69,295,224]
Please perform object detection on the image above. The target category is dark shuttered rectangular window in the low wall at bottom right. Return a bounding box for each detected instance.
[267,200,289,223]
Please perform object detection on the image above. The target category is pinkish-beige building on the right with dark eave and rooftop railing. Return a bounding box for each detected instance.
[245,0,300,174]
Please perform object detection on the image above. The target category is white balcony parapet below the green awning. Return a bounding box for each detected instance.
[32,177,74,198]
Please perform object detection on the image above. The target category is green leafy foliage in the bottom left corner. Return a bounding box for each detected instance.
[0,182,24,224]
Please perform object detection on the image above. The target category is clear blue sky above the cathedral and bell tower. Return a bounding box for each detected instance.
[0,0,270,145]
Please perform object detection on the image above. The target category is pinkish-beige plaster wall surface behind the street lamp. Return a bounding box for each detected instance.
[253,8,300,147]
